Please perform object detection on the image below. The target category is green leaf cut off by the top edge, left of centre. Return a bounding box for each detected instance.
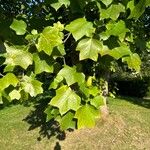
[51,0,70,11]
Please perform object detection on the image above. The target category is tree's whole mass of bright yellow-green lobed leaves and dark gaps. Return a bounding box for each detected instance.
[0,0,150,130]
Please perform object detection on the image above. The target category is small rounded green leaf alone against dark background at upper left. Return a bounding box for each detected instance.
[10,19,27,35]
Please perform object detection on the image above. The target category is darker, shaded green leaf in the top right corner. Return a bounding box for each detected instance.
[128,0,148,19]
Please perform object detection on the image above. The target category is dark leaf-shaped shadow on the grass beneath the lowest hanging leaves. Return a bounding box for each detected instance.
[23,92,66,150]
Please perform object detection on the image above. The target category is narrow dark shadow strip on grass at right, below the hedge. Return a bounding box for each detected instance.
[119,96,150,109]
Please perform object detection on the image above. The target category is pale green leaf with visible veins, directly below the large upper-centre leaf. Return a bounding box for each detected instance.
[76,38,102,61]
